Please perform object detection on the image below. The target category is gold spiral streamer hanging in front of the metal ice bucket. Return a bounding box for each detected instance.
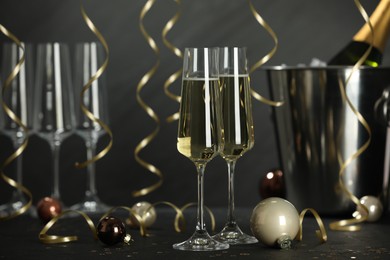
[329,0,374,231]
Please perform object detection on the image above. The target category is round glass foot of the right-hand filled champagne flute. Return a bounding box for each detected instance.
[213,224,258,245]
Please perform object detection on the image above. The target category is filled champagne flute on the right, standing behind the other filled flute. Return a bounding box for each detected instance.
[214,47,257,244]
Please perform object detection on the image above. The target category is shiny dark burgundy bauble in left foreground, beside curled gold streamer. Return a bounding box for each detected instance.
[97,216,126,246]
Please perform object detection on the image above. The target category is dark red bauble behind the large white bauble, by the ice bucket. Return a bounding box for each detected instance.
[259,169,286,199]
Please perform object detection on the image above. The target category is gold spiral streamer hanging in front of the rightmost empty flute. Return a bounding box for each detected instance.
[75,1,113,169]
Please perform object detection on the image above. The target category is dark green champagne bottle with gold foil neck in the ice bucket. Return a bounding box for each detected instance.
[328,0,390,67]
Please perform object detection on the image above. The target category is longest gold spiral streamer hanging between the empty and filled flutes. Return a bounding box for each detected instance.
[132,0,163,197]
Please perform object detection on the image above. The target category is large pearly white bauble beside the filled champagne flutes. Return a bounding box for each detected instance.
[250,197,299,248]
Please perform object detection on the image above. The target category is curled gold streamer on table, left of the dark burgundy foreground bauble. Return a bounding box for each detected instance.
[38,210,98,244]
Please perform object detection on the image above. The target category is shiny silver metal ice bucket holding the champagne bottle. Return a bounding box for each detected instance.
[265,66,390,215]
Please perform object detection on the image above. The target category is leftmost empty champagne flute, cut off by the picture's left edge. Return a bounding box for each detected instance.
[0,43,33,215]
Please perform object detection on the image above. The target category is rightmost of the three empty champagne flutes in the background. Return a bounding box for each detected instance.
[70,42,110,213]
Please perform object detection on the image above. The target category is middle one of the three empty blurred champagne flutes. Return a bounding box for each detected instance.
[34,42,74,202]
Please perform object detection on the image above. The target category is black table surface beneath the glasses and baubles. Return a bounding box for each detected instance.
[0,208,390,260]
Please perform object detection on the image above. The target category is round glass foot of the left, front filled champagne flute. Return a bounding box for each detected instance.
[173,230,229,251]
